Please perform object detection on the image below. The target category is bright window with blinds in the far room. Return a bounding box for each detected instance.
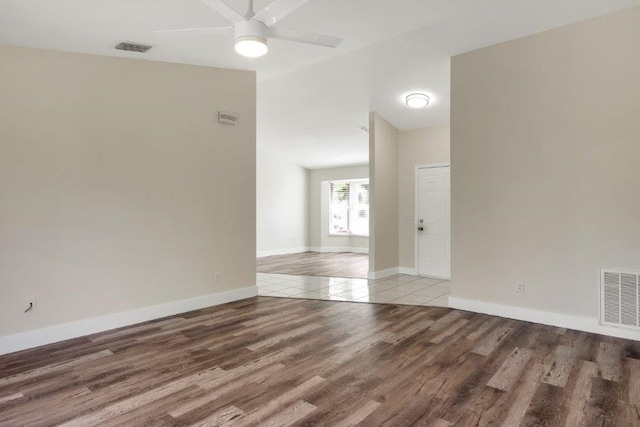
[329,180,369,236]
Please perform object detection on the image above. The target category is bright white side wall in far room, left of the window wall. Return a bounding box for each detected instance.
[256,149,309,257]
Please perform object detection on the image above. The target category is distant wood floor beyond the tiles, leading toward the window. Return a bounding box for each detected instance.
[256,252,369,279]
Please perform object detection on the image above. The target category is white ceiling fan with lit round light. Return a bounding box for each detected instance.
[156,0,342,58]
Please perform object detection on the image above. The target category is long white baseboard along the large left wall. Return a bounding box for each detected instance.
[0,286,258,355]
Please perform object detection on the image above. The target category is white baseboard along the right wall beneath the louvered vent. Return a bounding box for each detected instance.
[449,297,640,341]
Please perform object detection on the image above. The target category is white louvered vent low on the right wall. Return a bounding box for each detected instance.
[600,269,640,330]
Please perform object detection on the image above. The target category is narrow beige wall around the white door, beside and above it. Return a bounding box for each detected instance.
[398,125,450,269]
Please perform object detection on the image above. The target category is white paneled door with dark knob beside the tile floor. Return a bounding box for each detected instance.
[416,166,451,279]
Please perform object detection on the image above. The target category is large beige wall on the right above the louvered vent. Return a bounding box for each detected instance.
[451,8,640,318]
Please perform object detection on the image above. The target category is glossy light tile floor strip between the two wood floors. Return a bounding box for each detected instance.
[256,273,450,307]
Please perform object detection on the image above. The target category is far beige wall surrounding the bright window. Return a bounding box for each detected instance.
[309,165,369,250]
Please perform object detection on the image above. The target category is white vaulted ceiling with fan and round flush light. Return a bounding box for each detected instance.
[0,0,640,168]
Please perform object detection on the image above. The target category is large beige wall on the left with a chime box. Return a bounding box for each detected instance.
[0,46,256,336]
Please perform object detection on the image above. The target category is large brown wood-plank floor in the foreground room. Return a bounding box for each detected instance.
[0,297,640,426]
